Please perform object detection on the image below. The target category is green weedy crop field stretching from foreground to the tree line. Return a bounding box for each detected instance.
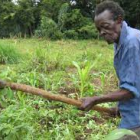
[0,39,119,140]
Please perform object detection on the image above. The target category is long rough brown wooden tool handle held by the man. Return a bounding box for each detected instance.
[0,80,112,114]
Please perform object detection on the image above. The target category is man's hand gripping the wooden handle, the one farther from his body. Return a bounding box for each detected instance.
[79,96,98,111]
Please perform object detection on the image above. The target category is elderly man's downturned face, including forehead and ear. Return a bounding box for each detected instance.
[94,10,122,44]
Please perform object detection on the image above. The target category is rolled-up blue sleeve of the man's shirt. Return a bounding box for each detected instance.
[120,38,140,98]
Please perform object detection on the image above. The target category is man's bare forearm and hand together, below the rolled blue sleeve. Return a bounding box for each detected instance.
[80,89,134,111]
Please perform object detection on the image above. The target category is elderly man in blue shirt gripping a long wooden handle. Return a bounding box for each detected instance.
[81,1,140,139]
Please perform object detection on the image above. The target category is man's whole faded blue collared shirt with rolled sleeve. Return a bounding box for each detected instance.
[114,21,140,129]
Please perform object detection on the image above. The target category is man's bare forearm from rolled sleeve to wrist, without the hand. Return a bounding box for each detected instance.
[93,89,134,104]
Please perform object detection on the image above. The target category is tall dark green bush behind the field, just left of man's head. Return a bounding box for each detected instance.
[58,3,98,39]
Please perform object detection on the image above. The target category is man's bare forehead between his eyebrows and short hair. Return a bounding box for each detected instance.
[94,10,113,21]
